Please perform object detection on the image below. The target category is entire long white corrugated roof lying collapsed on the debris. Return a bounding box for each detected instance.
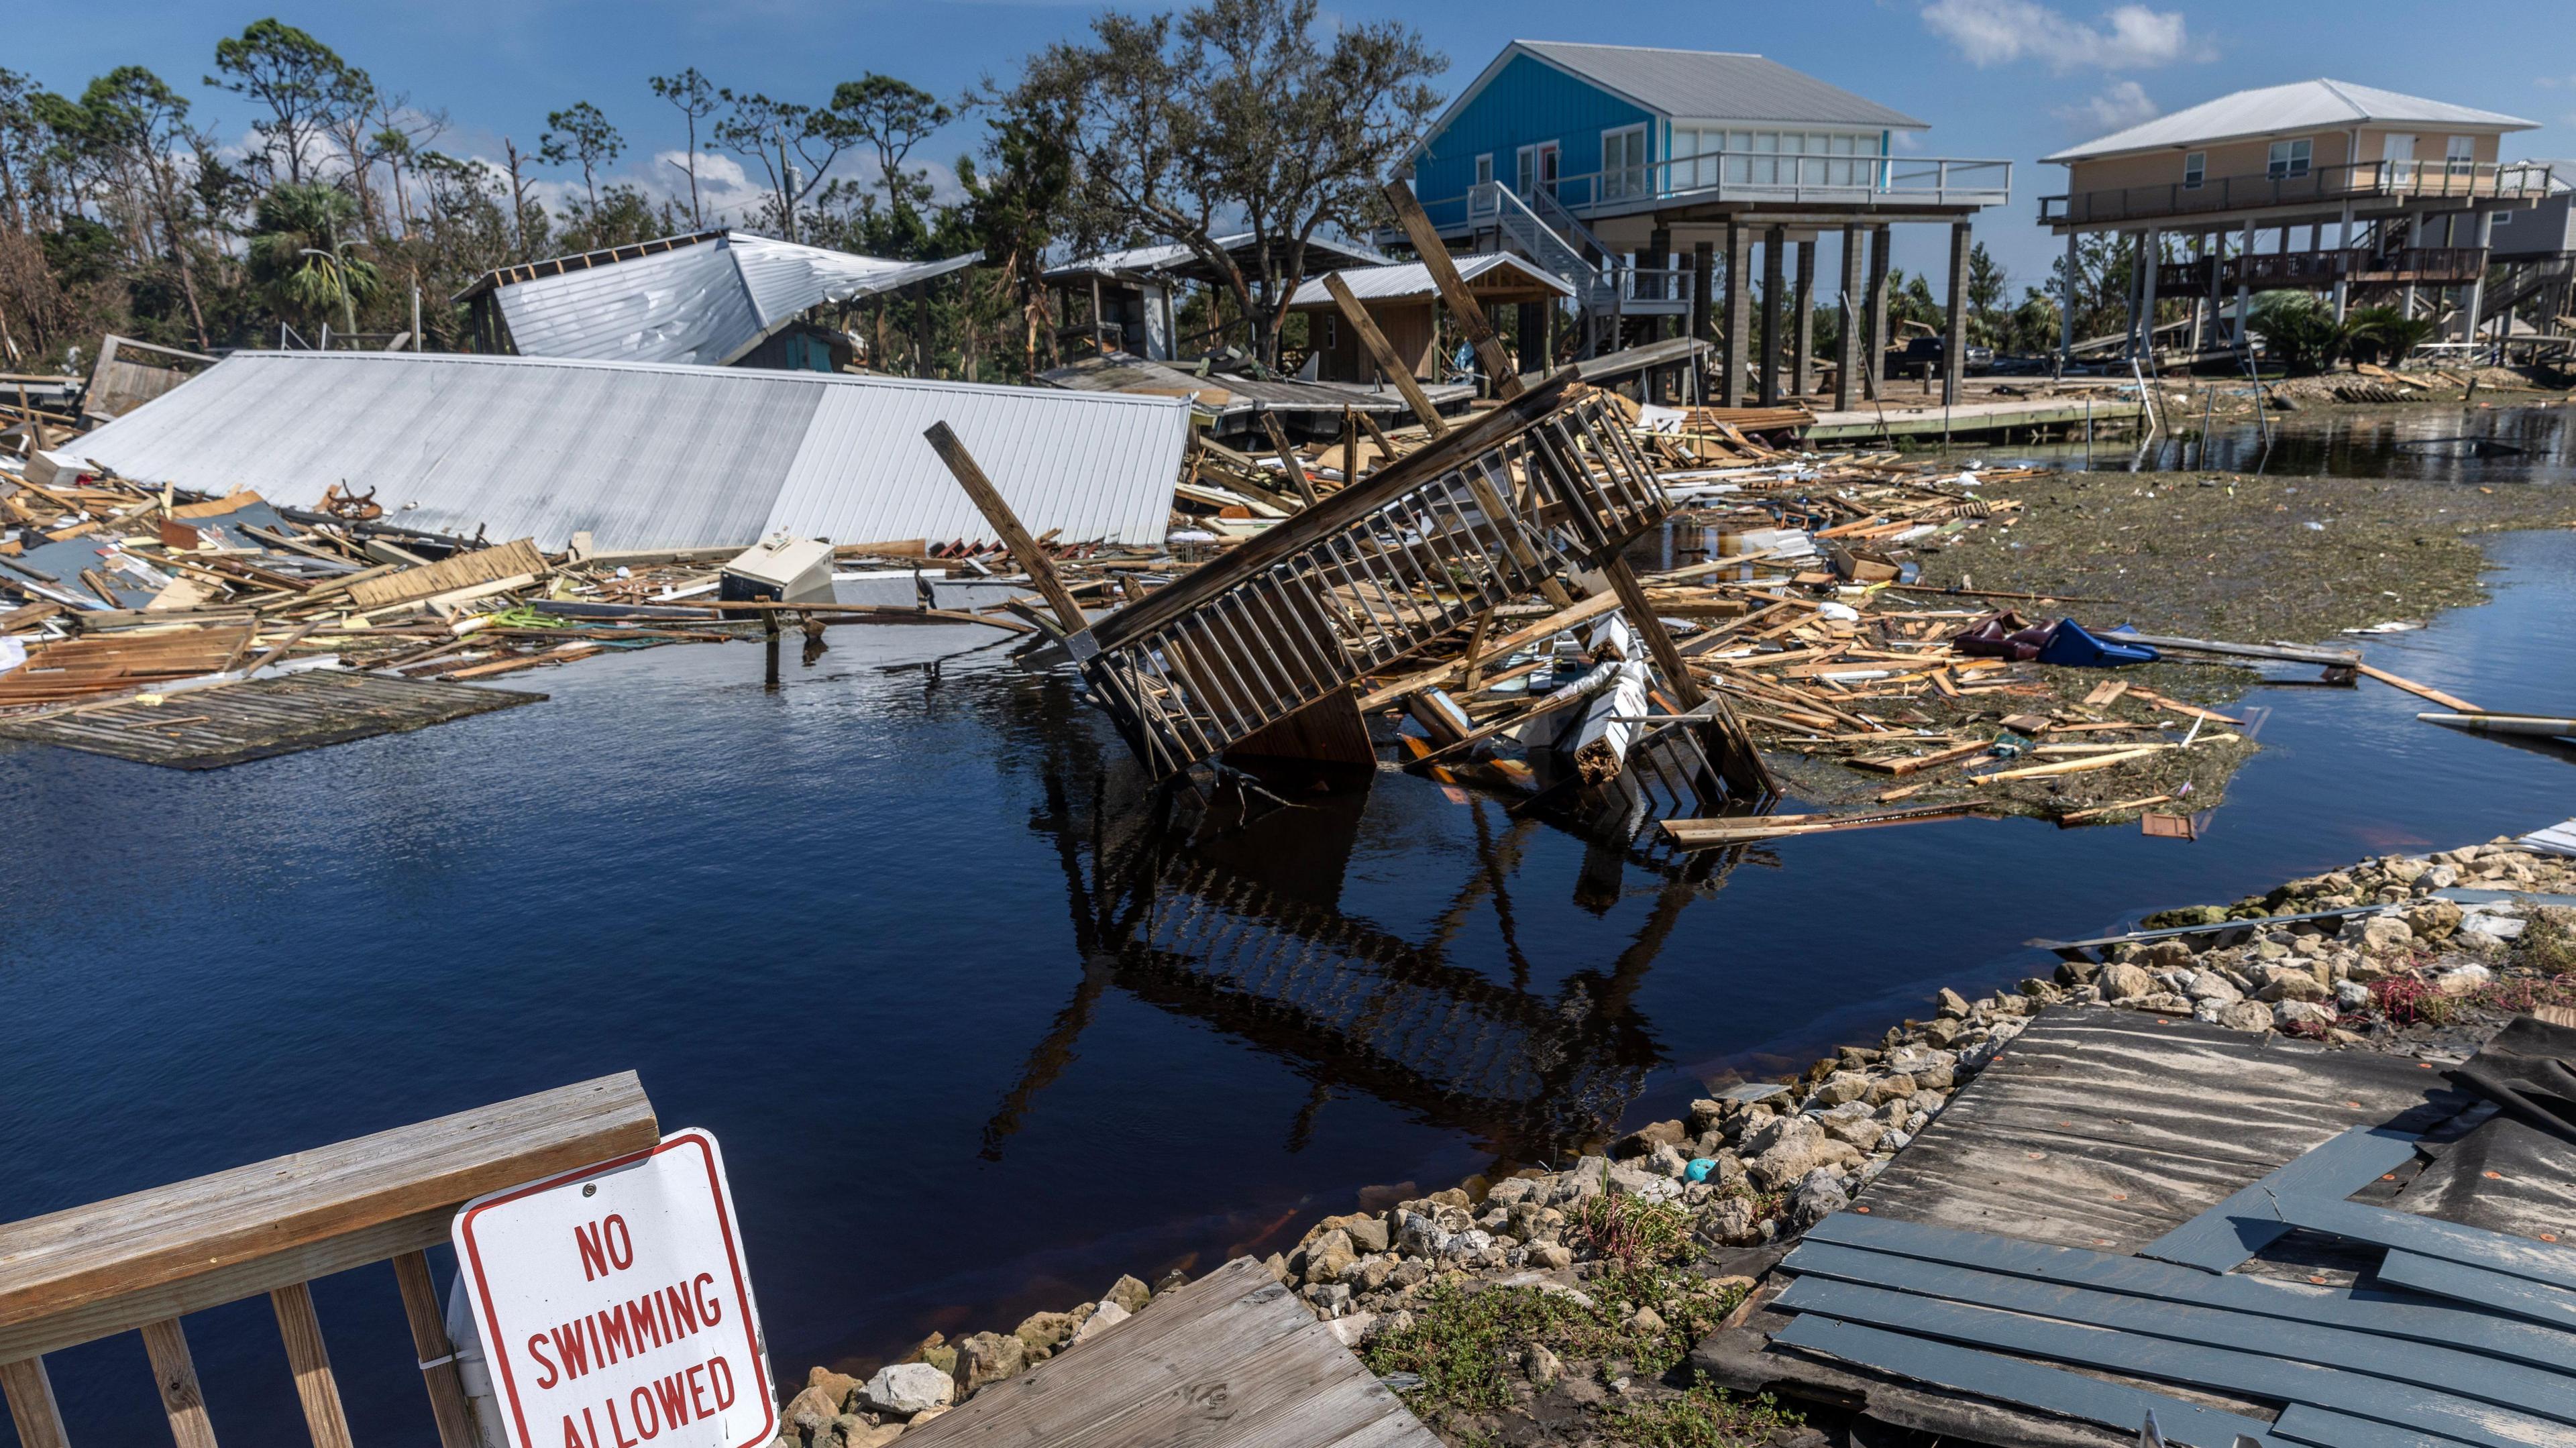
[74,353,1190,549]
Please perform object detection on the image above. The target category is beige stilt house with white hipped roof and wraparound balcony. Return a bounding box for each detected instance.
[2040,80,2551,353]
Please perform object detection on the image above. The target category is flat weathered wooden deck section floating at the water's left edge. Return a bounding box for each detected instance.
[0,670,546,771]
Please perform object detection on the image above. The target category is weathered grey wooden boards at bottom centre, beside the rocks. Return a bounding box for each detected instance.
[904,1258,1440,1448]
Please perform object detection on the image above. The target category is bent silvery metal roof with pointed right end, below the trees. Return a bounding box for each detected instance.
[494,232,981,366]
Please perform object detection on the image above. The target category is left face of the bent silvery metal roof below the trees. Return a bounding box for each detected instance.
[500,242,763,364]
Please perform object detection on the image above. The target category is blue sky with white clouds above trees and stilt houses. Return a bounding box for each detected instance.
[20,0,2576,294]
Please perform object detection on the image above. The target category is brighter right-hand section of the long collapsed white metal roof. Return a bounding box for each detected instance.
[770,379,1190,544]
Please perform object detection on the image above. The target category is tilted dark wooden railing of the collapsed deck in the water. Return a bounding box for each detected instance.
[1069,374,1669,775]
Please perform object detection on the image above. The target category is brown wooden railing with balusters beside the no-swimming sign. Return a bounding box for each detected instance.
[0,1072,659,1448]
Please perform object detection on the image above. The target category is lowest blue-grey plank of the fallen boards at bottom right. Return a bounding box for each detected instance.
[1772,1317,2275,1448]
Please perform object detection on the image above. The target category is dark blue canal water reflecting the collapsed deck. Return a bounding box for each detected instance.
[0,402,2576,1443]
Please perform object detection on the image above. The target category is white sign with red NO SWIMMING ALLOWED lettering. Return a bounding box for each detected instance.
[451,1131,778,1448]
